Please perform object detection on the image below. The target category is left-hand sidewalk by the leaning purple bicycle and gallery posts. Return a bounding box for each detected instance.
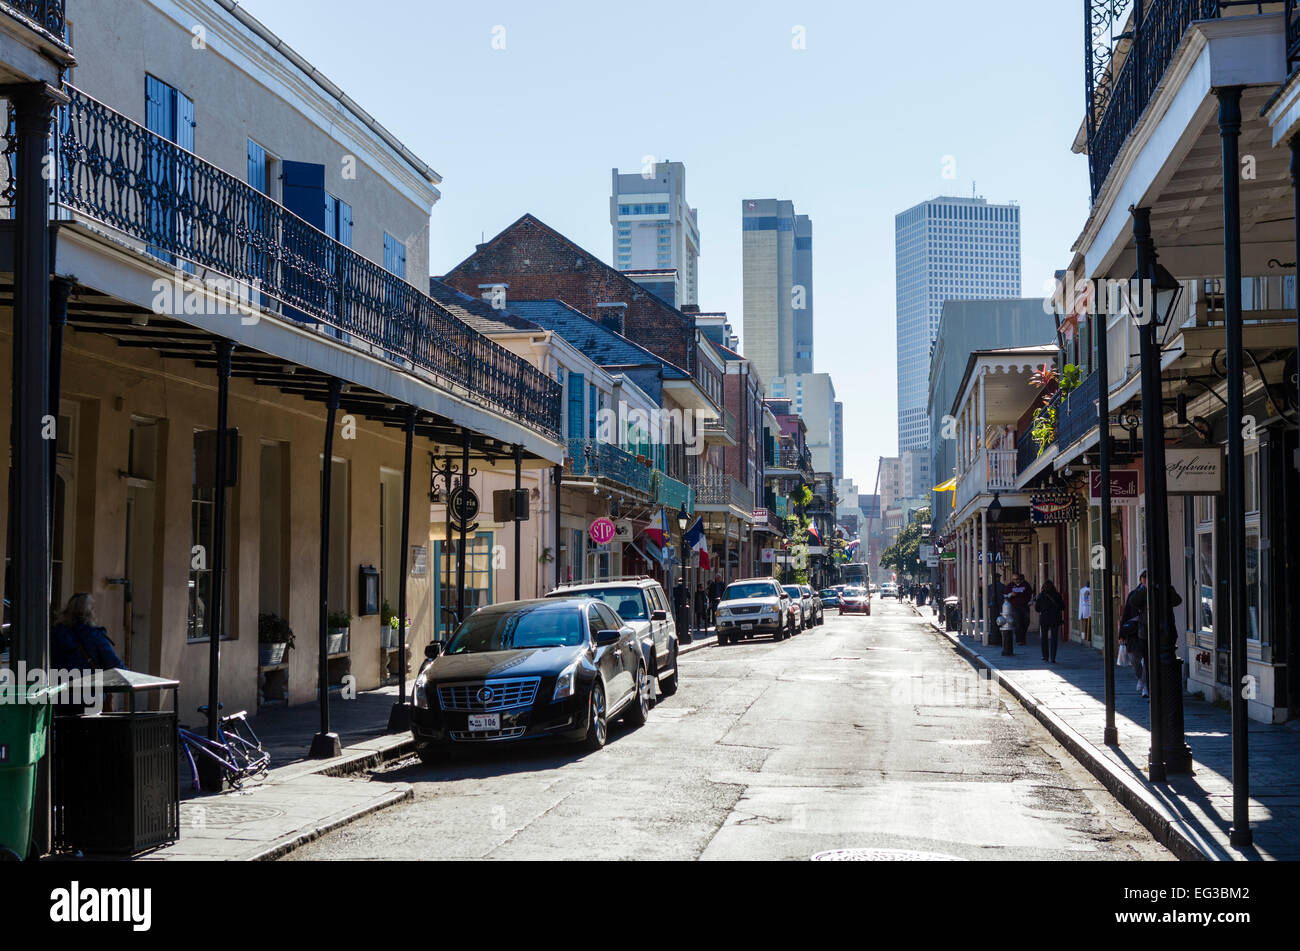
[138,629,718,861]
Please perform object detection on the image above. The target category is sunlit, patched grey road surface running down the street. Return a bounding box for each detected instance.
[289,600,1173,861]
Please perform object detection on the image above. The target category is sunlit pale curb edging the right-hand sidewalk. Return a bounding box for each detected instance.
[913,605,1211,861]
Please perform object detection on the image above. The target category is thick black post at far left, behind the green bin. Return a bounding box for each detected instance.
[5,84,66,855]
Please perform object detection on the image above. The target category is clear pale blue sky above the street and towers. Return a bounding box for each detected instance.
[243,0,1087,492]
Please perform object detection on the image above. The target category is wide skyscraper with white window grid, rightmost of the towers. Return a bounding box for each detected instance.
[894,197,1021,452]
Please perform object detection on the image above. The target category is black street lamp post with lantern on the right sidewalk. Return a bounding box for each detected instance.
[1128,208,1192,782]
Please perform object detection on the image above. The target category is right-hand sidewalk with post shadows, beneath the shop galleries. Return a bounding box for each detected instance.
[922,602,1300,860]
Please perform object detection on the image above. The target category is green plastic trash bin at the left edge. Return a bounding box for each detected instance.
[0,687,56,860]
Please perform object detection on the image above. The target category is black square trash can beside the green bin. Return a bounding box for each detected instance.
[53,670,181,856]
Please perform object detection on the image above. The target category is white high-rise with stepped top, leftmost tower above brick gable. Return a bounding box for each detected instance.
[610,162,699,307]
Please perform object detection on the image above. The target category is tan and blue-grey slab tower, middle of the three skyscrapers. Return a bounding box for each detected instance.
[741,199,813,379]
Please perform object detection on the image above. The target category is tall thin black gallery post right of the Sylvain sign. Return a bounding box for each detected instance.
[1217,86,1253,848]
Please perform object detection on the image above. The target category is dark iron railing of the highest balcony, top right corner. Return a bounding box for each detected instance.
[1084,0,1227,200]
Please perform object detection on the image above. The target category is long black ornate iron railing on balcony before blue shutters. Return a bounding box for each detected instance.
[57,87,560,437]
